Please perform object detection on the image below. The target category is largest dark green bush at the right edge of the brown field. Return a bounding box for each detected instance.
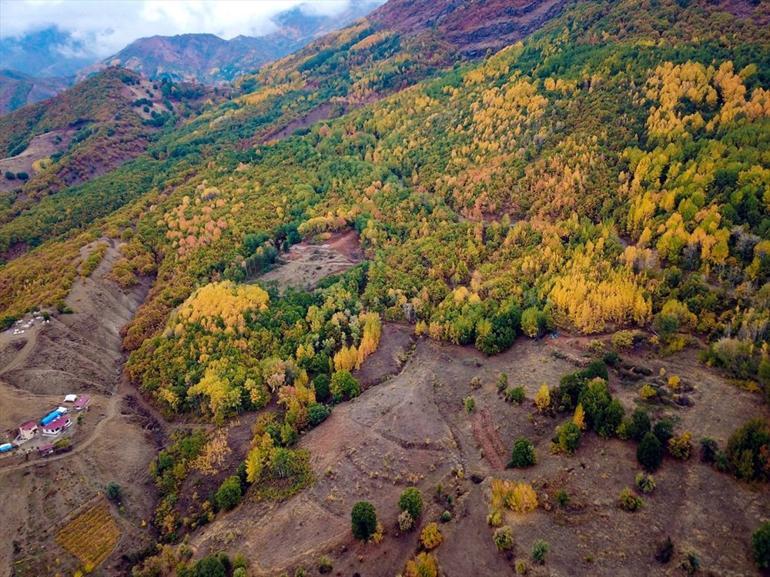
[725,419,770,481]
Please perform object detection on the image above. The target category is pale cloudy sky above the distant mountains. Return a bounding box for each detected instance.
[0,0,368,56]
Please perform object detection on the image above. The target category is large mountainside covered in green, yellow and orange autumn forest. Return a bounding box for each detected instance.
[0,0,770,575]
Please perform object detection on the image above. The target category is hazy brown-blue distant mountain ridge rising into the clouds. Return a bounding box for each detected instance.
[80,0,382,84]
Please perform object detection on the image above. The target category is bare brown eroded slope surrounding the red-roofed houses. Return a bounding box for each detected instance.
[0,240,160,577]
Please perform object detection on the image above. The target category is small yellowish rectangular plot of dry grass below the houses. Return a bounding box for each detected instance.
[56,501,120,571]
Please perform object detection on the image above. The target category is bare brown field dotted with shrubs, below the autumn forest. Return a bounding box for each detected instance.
[186,331,770,577]
